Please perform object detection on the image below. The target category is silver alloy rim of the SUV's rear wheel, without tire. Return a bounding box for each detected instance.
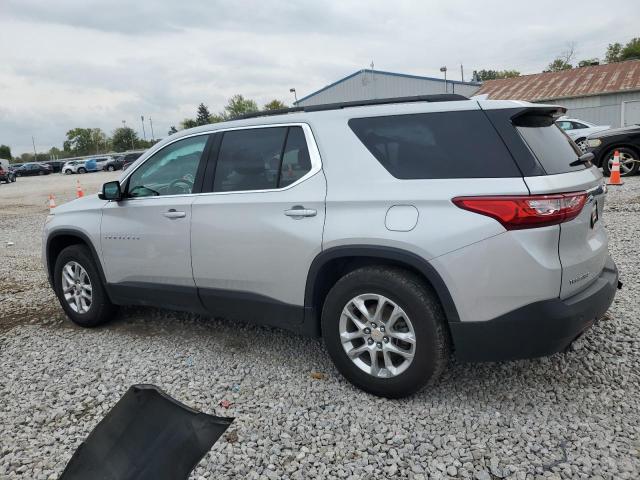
[338,293,416,378]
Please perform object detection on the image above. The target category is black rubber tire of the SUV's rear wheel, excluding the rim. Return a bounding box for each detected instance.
[322,266,450,398]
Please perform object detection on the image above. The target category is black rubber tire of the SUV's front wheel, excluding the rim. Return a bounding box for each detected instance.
[53,245,117,328]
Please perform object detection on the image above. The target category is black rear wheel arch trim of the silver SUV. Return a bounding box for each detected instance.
[304,245,460,332]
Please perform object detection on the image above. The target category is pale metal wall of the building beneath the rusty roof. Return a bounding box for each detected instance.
[544,92,640,128]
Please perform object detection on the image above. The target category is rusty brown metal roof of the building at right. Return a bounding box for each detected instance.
[476,60,640,101]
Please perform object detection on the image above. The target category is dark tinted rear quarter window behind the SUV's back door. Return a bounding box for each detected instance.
[349,111,520,179]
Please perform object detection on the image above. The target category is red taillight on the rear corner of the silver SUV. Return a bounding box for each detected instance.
[452,192,587,230]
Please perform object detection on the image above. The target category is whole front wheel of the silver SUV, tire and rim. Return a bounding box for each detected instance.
[53,245,117,327]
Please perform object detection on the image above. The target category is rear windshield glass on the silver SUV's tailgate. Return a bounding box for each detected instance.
[516,124,588,175]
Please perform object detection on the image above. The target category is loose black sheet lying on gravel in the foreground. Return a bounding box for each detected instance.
[60,385,233,480]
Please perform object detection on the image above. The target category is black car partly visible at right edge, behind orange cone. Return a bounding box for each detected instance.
[587,125,640,177]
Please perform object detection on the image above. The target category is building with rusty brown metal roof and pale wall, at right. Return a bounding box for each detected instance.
[477,60,640,128]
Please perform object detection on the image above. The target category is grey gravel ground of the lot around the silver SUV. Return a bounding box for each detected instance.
[0,174,640,480]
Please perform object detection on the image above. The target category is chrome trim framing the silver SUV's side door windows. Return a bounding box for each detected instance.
[120,122,322,201]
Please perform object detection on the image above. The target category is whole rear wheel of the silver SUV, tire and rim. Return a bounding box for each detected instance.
[322,267,449,398]
